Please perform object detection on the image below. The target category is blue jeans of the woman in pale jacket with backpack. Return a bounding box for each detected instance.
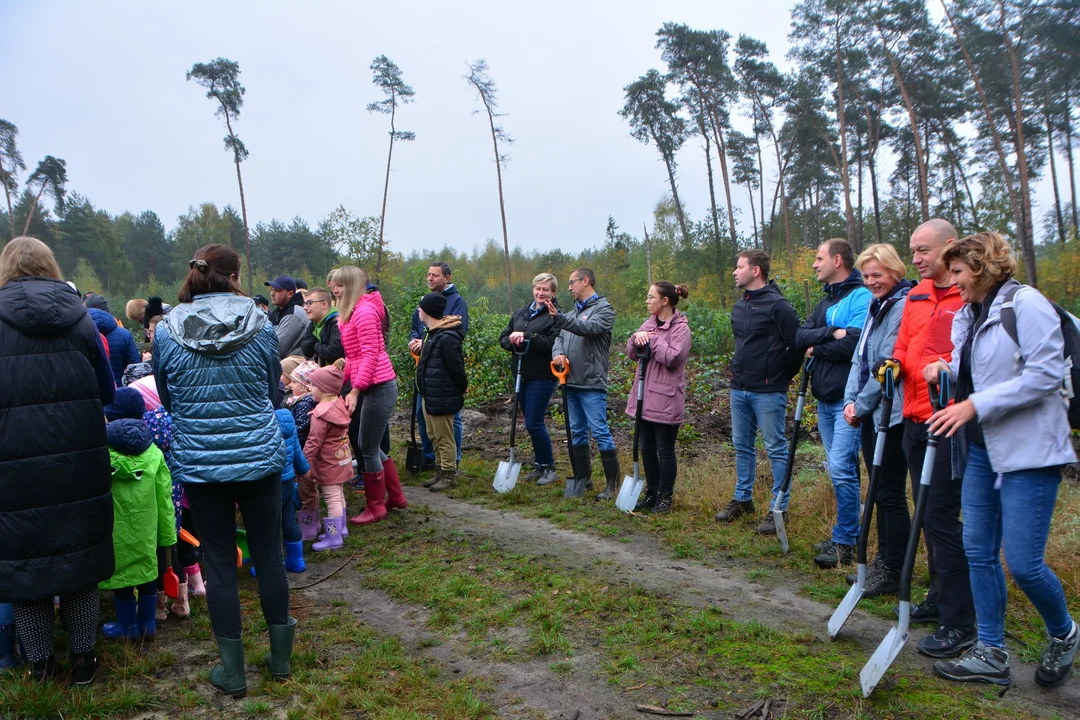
[962,443,1072,648]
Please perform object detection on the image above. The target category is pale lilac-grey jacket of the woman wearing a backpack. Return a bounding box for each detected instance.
[949,280,1077,473]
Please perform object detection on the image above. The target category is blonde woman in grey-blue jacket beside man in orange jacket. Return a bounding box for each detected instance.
[843,244,912,597]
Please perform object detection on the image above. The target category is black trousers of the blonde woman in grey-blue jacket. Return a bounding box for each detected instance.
[862,425,912,572]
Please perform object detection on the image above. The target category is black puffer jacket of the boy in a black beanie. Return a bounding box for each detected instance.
[416,315,469,416]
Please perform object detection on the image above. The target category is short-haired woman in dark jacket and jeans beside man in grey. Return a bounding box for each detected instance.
[499,272,558,485]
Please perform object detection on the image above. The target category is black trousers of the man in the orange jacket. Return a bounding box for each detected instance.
[904,419,975,625]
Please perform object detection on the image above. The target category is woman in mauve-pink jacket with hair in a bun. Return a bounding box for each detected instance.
[626,281,690,513]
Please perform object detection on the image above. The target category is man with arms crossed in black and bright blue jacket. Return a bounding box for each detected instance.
[795,237,870,568]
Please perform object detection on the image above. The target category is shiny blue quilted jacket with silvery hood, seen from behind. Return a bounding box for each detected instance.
[152,293,286,483]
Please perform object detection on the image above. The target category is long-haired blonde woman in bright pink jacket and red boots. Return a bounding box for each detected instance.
[335,266,408,525]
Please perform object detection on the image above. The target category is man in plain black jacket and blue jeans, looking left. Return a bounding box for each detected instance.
[716,250,799,534]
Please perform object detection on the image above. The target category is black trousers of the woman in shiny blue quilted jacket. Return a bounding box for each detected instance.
[184,475,288,640]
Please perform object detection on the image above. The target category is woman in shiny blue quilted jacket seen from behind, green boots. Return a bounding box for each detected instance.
[152,245,296,697]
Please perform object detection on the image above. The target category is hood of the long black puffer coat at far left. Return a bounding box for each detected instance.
[0,277,86,337]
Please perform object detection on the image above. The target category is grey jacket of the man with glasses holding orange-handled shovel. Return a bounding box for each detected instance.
[549,295,615,390]
